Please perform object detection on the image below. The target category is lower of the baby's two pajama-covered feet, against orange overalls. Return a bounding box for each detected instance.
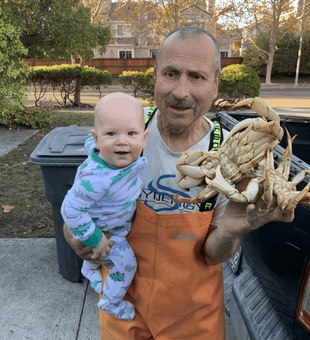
[98,294,135,321]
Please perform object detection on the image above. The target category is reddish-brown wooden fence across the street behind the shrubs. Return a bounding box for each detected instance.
[25,57,243,77]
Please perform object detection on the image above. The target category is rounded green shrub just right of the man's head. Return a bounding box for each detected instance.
[218,64,261,103]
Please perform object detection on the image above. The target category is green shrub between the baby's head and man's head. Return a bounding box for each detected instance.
[118,67,155,98]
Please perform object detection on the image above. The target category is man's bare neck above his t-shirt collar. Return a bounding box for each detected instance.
[157,112,210,152]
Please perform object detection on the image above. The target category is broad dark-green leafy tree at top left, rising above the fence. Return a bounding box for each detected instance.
[0,0,111,59]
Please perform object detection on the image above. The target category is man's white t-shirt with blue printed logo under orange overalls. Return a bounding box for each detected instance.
[139,108,228,225]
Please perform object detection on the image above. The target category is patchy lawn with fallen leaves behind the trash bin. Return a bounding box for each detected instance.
[0,112,94,238]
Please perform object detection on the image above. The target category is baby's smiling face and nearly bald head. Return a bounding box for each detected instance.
[93,96,148,168]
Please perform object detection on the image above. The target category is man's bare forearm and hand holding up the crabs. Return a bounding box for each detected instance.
[203,200,294,265]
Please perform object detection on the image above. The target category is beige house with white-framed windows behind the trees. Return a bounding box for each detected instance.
[94,0,236,58]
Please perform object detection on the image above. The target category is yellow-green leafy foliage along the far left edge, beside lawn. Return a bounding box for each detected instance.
[0,8,30,124]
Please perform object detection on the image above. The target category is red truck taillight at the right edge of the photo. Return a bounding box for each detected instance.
[296,261,310,332]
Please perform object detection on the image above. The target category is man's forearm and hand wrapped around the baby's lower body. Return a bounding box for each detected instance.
[63,224,113,266]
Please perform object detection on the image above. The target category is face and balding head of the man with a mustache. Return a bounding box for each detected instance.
[155,35,220,129]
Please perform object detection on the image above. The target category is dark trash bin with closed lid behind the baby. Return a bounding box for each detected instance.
[29,125,93,282]
